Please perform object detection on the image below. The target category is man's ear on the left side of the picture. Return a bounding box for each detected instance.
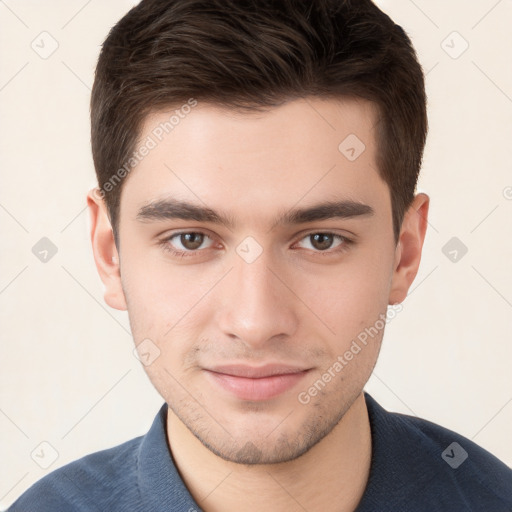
[87,188,127,311]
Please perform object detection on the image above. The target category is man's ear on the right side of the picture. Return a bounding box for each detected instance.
[389,193,430,304]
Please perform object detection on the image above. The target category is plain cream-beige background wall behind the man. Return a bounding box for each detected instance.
[0,0,512,508]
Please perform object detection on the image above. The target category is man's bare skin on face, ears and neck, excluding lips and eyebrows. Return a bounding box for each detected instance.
[88,98,429,512]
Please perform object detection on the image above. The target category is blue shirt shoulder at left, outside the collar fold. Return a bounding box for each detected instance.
[7,436,144,512]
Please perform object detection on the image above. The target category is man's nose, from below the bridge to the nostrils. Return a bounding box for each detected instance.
[217,251,299,349]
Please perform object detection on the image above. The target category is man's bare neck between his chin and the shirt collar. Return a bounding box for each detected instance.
[167,393,372,512]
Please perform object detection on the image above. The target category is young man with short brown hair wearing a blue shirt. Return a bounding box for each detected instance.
[10,0,512,512]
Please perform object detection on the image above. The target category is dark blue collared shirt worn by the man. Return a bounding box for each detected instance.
[8,392,512,512]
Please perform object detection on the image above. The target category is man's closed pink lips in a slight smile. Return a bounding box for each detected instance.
[205,364,309,401]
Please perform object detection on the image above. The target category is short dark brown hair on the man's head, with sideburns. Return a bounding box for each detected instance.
[91,0,427,247]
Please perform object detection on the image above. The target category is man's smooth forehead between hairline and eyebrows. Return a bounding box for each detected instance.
[121,98,389,228]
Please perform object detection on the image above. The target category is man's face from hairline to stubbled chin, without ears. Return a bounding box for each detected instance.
[94,98,418,464]
